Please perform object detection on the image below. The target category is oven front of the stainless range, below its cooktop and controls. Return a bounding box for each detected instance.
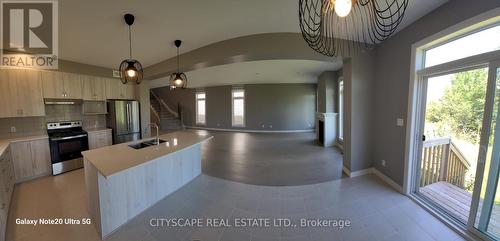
[50,134,89,175]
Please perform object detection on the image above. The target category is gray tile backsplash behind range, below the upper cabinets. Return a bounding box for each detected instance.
[0,105,106,139]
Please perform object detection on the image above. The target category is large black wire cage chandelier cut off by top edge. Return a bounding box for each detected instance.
[299,0,409,57]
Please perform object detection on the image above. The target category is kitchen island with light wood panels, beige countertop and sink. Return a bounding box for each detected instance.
[82,131,212,238]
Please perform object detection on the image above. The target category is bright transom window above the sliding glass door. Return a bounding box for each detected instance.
[425,26,500,68]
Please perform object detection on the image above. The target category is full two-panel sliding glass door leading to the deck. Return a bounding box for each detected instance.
[414,61,500,240]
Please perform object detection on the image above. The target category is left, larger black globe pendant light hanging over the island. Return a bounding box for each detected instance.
[119,13,143,84]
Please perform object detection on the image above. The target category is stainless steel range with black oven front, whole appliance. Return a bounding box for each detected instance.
[47,121,89,175]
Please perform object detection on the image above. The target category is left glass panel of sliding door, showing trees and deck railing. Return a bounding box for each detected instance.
[416,67,488,225]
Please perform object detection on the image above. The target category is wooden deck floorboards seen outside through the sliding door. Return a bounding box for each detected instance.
[420,182,500,235]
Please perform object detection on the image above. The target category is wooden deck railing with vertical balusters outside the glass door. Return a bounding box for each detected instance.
[420,137,470,188]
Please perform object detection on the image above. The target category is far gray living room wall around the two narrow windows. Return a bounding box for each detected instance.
[153,84,316,131]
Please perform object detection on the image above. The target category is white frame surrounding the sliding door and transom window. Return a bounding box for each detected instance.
[403,8,500,240]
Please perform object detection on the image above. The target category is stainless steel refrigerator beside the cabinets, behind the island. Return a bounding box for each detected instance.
[106,100,141,144]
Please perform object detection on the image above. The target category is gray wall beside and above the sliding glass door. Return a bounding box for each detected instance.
[372,0,500,185]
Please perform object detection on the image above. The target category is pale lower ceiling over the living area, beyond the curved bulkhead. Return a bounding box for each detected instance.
[150,60,342,88]
